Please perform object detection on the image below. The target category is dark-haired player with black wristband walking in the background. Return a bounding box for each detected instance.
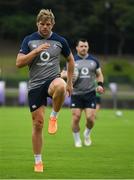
[61,39,104,147]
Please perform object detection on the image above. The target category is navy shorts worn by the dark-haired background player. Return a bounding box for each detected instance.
[71,91,96,109]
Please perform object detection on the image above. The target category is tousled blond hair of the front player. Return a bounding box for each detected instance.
[37,9,55,24]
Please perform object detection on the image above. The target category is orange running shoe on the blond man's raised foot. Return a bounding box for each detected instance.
[48,117,57,134]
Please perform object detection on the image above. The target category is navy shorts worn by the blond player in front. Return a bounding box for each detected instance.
[28,79,53,112]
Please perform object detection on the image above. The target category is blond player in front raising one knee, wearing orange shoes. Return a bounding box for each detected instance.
[16,9,74,172]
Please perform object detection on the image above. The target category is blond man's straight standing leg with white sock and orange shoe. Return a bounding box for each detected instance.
[32,106,44,172]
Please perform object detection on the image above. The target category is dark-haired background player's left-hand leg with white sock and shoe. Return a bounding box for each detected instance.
[72,108,82,147]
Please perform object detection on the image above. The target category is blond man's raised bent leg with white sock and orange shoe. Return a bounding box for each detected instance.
[48,78,66,134]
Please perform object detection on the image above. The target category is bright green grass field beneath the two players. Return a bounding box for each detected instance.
[0,107,134,179]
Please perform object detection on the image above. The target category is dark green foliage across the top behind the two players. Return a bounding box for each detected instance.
[0,0,134,54]
